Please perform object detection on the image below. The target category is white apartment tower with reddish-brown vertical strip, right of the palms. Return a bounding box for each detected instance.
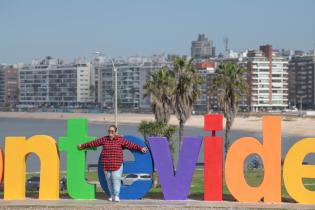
[246,45,288,111]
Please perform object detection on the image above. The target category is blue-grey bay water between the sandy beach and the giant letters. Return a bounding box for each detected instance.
[0,118,314,172]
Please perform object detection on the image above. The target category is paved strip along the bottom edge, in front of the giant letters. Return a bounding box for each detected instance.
[0,199,315,210]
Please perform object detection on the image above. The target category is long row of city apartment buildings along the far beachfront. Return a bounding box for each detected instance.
[0,44,315,113]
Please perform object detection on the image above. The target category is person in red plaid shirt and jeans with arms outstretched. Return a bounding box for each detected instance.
[78,125,148,202]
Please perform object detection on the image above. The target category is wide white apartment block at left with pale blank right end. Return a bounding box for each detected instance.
[19,57,93,107]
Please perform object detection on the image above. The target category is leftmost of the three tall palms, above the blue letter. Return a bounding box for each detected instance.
[144,67,175,123]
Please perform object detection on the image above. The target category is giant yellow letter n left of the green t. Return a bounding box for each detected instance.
[4,135,60,200]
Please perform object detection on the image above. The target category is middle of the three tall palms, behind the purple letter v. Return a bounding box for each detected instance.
[173,57,203,148]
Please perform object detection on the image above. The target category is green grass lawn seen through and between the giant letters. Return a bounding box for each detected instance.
[12,170,315,202]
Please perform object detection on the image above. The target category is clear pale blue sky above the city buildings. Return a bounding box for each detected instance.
[0,0,315,63]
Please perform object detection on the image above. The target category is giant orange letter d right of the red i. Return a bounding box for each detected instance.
[225,116,281,202]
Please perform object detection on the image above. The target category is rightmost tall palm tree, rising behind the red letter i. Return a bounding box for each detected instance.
[211,62,248,154]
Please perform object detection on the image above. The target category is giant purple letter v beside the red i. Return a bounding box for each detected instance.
[149,137,202,200]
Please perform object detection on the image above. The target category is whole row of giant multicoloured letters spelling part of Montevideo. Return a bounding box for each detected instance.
[0,114,315,204]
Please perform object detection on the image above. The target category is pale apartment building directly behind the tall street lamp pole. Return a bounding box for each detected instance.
[92,56,168,111]
